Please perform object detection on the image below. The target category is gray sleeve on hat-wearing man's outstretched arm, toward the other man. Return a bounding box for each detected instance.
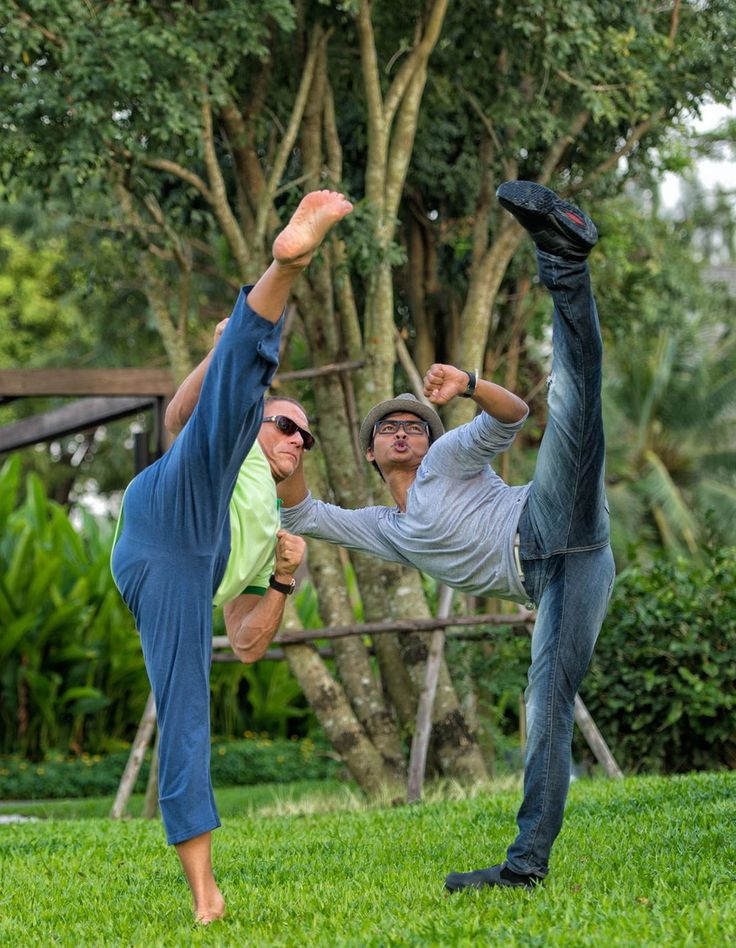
[281,492,411,566]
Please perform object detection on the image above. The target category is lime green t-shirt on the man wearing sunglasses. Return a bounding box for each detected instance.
[213,441,281,606]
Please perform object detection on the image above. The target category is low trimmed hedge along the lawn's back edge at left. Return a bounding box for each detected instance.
[0,735,340,800]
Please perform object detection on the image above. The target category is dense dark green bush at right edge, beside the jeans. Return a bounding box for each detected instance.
[583,548,736,773]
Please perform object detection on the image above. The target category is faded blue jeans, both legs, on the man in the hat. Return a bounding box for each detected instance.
[507,251,614,877]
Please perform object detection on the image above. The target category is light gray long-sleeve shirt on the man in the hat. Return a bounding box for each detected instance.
[281,412,531,601]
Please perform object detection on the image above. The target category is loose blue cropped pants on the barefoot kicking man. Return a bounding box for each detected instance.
[112,288,283,843]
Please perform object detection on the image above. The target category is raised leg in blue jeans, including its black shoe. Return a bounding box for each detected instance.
[497,181,608,559]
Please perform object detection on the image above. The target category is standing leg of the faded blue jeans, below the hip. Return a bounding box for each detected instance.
[506,545,614,876]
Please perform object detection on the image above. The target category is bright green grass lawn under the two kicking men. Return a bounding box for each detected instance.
[0,774,736,948]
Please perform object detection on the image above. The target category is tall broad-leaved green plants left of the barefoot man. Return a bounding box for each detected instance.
[0,456,148,756]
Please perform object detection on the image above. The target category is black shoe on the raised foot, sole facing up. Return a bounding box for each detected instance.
[496,181,598,260]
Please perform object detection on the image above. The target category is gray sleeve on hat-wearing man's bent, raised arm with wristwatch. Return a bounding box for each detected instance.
[422,409,529,478]
